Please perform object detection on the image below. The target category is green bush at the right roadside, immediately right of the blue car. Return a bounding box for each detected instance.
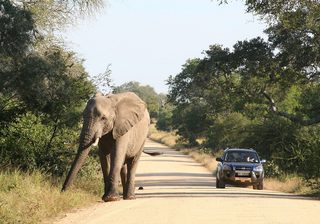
[247,117,320,184]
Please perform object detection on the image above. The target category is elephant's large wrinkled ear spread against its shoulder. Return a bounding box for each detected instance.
[112,93,146,139]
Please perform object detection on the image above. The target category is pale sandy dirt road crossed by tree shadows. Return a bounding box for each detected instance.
[56,141,320,224]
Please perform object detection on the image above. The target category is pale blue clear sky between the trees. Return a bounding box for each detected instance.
[64,0,266,93]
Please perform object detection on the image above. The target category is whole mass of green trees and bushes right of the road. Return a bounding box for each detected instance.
[168,0,320,184]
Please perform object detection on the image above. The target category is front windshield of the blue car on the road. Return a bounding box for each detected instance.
[225,151,259,163]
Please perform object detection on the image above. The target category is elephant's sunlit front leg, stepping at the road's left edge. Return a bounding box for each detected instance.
[102,141,127,202]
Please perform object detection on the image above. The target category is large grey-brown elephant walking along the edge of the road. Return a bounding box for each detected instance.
[62,92,150,202]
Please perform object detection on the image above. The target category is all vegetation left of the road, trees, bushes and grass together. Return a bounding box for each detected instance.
[0,0,102,224]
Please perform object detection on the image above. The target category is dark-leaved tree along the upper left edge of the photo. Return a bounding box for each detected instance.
[0,0,35,127]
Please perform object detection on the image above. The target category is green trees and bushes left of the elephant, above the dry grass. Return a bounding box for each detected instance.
[0,0,95,176]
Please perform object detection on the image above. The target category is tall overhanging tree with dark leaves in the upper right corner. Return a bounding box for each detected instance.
[220,0,320,125]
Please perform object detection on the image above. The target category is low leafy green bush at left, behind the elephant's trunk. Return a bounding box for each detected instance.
[0,113,98,176]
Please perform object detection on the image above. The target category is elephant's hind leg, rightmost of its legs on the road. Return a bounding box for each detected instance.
[124,152,141,200]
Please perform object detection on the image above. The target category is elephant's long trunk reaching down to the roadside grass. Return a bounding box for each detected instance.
[61,120,93,191]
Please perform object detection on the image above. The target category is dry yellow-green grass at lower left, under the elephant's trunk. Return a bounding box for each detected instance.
[0,170,102,224]
